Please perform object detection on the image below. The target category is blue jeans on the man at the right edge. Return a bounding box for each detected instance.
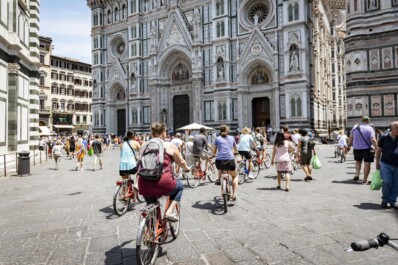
[380,162,398,204]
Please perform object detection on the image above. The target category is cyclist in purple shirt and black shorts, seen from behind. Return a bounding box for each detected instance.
[213,125,238,200]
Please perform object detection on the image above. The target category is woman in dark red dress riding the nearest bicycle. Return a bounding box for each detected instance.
[138,122,190,221]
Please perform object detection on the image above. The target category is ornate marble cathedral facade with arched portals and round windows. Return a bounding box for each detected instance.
[87,0,345,134]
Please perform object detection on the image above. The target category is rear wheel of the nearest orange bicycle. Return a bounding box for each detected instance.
[135,217,160,265]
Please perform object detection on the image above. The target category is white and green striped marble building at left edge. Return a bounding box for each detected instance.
[0,0,40,154]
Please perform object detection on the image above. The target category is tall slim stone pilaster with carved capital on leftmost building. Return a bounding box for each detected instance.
[7,63,20,152]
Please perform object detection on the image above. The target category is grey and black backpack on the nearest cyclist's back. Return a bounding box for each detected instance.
[137,138,164,181]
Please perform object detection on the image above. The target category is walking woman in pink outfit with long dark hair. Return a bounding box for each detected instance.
[271,132,294,191]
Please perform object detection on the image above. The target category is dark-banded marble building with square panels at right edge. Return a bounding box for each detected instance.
[345,0,398,128]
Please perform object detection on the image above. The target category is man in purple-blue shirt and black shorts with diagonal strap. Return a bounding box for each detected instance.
[348,116,377,185]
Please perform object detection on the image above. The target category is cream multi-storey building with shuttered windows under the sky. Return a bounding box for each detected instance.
[39,37,93,135]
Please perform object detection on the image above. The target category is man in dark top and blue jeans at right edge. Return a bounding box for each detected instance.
[376,121,398,209]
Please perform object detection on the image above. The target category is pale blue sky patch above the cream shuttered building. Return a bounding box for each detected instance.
[40,0,91,64]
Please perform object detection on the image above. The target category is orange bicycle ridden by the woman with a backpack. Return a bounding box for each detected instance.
[136,197,180,265]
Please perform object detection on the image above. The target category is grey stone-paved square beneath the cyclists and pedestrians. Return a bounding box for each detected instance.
[0,145,398,265]
